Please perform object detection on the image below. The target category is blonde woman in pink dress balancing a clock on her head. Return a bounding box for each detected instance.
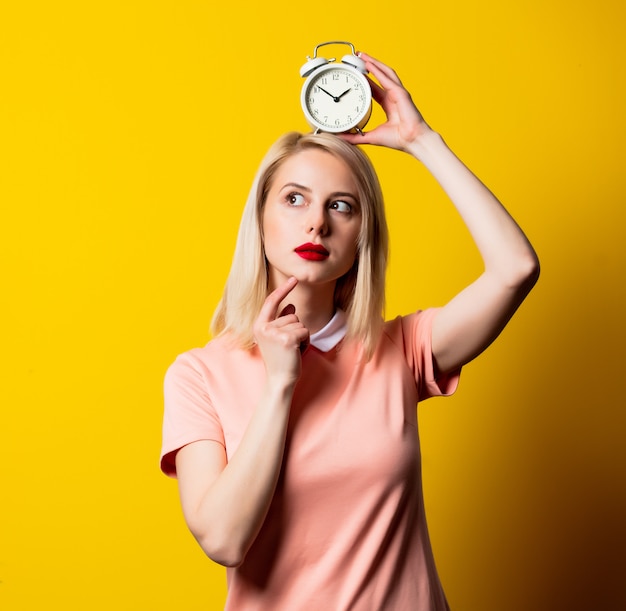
[161,54,539,611]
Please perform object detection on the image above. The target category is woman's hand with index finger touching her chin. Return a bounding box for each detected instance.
[253,277,309,386]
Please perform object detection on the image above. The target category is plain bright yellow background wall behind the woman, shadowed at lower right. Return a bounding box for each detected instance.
[0,0,626,611]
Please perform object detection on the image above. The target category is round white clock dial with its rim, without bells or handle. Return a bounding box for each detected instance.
[302,64,372,133]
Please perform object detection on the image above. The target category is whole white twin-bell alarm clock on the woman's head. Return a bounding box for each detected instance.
[300,40,372,134]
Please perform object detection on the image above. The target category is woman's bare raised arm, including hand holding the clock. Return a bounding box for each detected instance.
[342,53,539,372]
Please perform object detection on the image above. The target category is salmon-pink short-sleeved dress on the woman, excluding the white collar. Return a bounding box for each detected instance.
[161,309,460,611]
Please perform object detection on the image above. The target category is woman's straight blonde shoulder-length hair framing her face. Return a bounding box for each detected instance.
[211,132,389,358]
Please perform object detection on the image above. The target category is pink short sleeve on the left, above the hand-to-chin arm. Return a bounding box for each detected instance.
[161,351,224,477]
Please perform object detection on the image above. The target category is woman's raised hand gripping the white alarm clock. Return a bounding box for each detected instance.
[340,53,432,152]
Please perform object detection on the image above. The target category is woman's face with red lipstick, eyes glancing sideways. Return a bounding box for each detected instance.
[262,149,361,288]
